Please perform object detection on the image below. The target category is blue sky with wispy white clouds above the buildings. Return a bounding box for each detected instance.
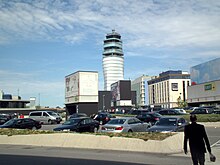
[0,0,220,107]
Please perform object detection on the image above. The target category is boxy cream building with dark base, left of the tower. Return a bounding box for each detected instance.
[65,71,98,115]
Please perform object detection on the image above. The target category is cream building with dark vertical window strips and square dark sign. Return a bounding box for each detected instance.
[148,70,190,108]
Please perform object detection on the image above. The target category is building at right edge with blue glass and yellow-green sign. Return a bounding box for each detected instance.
[187,58,220,107]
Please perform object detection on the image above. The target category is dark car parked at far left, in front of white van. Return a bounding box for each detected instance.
[0,118,41,130]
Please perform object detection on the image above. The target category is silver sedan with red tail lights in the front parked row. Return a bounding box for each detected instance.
[101,117,149,133]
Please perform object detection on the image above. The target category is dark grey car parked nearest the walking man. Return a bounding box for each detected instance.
[148,116,188,132]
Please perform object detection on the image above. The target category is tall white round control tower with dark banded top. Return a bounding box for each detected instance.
[102,30,124,91]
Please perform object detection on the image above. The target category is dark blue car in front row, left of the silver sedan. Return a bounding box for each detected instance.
[53,117,99,132]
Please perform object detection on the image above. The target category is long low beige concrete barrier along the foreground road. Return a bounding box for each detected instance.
[0,133,183,153]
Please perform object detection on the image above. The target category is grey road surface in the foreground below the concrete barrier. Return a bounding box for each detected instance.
[0,145,191,165]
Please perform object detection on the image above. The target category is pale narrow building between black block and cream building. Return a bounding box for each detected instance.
[131,75,151,107]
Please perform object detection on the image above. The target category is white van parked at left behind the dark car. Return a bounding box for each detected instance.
[29,111,62,124]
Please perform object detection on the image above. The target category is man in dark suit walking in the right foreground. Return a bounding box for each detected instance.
[184,114,211,165]
